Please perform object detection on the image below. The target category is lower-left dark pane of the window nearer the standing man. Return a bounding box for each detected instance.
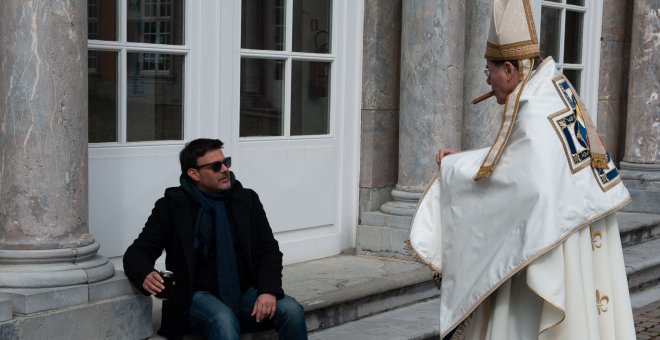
[240,58,284,137]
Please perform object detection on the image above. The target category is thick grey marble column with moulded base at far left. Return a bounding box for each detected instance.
[0,0,114,288]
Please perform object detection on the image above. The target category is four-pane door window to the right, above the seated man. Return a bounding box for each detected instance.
[239,0,335,137]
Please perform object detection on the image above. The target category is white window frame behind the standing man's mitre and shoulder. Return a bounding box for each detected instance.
[533,0,603,124]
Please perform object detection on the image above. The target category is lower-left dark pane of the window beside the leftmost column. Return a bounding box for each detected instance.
[87,51,118,143]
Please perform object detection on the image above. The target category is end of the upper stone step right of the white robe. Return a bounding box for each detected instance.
[616,212,660,247]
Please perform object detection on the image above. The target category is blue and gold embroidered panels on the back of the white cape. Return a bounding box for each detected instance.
[548,75,621,191]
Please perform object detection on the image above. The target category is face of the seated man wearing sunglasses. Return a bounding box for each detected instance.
[188,149,231,193]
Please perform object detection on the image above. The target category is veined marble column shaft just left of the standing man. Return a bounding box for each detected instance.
[396,0,465,192]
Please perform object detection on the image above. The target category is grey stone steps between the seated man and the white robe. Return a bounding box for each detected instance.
[150,255,440,340]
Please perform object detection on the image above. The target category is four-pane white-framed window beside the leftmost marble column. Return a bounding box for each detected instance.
[88,0,189,143]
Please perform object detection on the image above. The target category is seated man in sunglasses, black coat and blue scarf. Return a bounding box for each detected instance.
[124,139,307,339]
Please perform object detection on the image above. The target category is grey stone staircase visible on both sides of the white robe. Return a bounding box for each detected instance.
[154,212,660,340]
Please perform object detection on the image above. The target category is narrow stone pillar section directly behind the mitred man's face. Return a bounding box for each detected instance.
[461,0,503,150]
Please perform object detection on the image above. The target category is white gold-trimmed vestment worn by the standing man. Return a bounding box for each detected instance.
[410,59,635,340]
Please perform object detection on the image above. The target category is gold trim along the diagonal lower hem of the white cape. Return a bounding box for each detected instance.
[440,197,631,338]
